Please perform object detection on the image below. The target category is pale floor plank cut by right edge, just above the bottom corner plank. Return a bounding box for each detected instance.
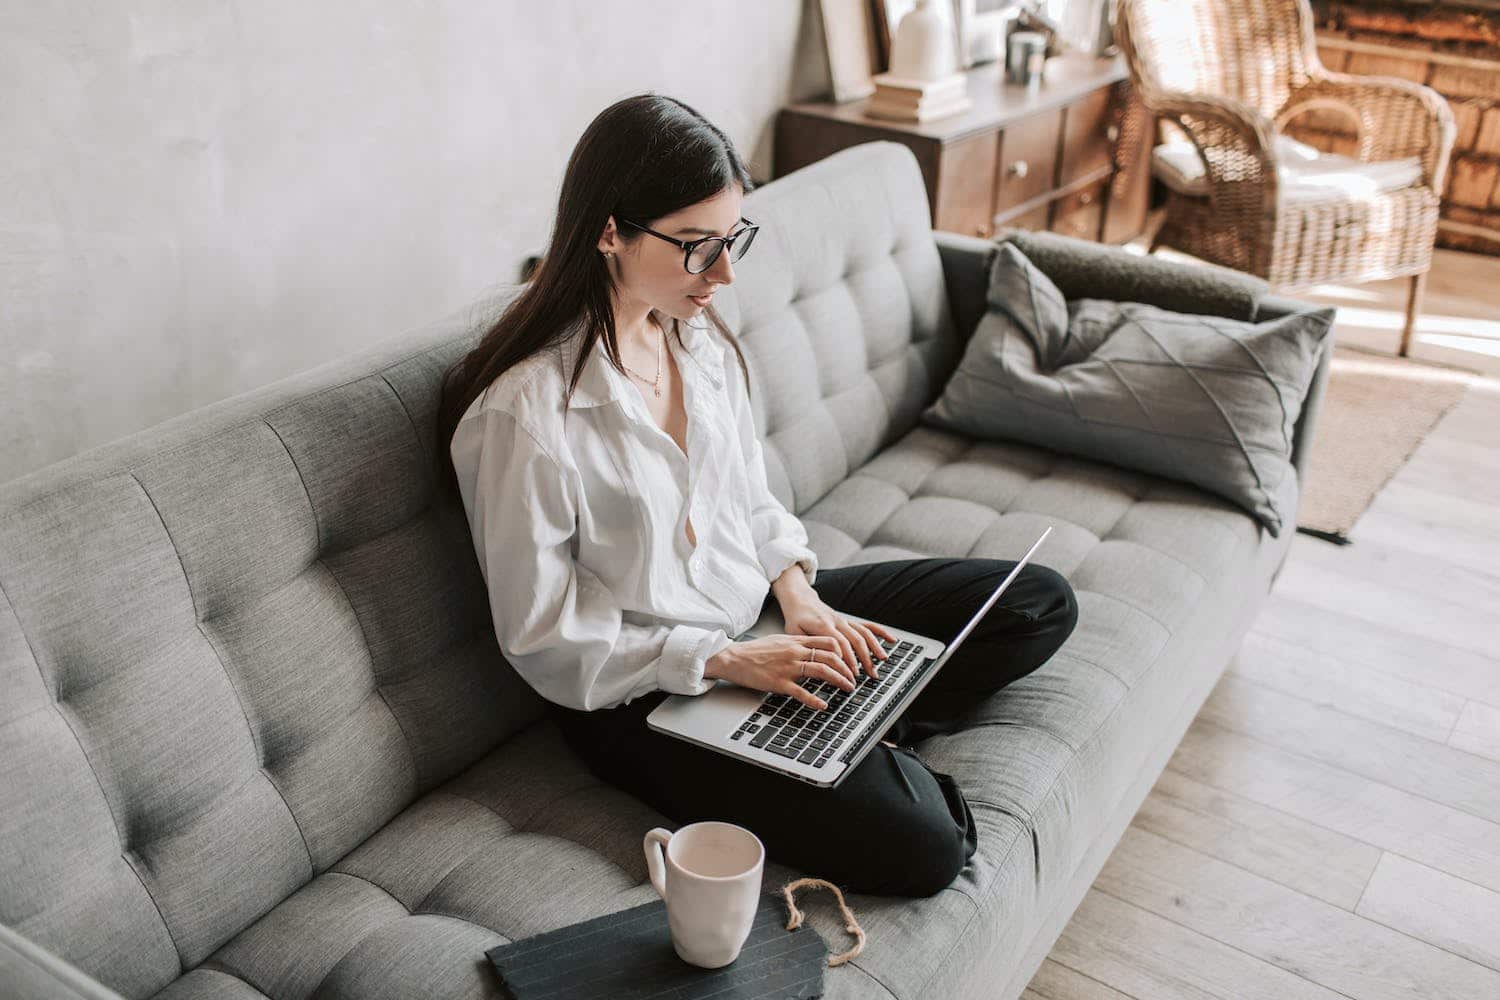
[1356,855,1500,977]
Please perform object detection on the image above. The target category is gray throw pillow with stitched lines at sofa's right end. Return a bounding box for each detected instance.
[923,243,1334,537]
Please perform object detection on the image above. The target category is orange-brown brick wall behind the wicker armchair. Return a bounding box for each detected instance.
[1287,1,1500,255]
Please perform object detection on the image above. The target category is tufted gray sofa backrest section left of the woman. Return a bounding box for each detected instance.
[0,284,543,996]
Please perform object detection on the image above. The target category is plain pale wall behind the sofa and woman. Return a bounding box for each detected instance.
[0,0,828,481]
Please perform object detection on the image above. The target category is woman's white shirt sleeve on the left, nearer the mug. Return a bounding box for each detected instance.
[452,409,731,712]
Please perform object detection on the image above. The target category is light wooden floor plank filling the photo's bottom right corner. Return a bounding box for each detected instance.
[1092,826,1500,1000]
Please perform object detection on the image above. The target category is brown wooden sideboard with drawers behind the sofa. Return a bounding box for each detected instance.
[773,54,1154,243]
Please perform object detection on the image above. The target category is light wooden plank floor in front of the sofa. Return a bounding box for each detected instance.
[1023,248,1500,1000]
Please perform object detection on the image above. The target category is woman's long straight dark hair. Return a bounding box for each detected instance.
[435,93,755,495]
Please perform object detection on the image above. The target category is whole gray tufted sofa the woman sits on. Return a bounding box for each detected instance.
[0,142,1328,1000]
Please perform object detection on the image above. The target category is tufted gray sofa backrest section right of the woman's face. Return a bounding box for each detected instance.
[716,141,963,514]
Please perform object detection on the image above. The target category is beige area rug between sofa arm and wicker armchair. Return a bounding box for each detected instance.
[1298,345,1475,544]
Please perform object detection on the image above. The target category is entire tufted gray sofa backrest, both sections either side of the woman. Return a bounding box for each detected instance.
[0,142,959,996]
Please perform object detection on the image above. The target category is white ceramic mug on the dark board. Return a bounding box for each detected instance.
[644,820,765,969]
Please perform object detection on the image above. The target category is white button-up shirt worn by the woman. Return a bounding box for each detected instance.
[450,312,818,711]
